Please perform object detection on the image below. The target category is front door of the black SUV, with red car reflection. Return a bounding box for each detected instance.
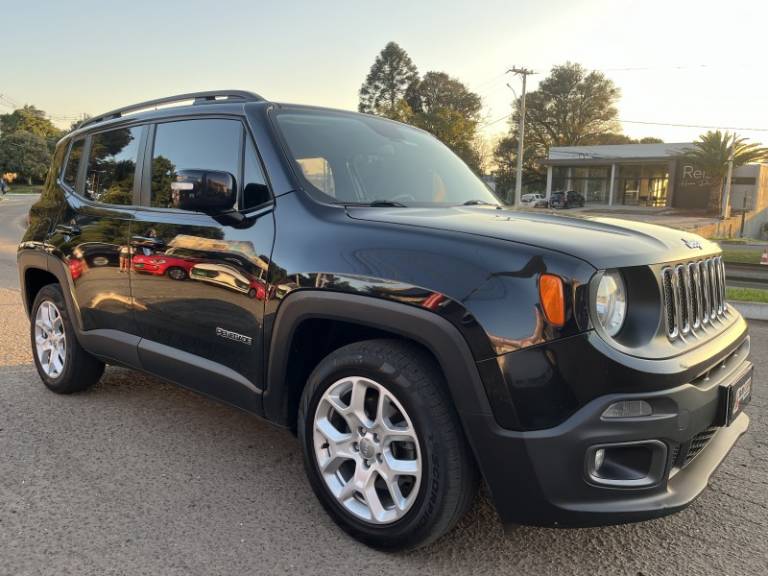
[131,118,274,411]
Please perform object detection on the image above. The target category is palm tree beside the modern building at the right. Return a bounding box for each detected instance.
[685,130,768,214]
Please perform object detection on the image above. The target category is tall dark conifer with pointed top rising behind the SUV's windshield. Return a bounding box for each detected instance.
[358,42,419,120]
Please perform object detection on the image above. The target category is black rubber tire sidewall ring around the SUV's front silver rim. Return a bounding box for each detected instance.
[298,354,446,548]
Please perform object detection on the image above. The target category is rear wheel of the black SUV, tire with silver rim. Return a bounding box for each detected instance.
[30,284,104,394]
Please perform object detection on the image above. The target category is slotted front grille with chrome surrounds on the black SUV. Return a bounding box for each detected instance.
[661,256,728,340]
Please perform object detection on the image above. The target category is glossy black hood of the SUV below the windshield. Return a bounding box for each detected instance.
[347,206,720,269]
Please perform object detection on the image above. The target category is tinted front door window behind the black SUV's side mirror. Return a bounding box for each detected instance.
[151,119,243,208]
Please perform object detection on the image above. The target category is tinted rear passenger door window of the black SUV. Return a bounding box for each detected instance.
[85,127,142,205]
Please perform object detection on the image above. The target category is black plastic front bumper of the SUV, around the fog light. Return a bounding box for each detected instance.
[464,328,752,526]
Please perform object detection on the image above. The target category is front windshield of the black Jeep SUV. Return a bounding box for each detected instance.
[277,110,499,206]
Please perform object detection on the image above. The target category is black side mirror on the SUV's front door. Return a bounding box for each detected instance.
[171,170,237,213]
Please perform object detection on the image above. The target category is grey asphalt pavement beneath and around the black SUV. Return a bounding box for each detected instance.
[0,195,768,576]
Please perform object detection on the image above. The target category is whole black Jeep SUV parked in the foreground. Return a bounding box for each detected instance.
[18,91,752,549]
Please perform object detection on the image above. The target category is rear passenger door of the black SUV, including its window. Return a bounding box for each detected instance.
[49,126,147,335]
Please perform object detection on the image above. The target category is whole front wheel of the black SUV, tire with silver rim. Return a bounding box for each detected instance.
[297,340,478,551]
